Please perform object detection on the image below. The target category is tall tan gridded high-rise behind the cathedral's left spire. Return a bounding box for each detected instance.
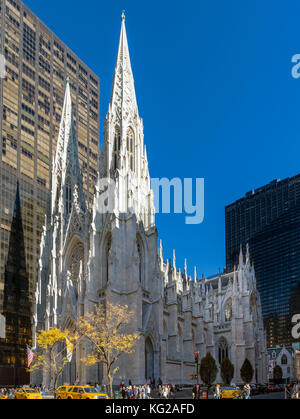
[0,0,100,382]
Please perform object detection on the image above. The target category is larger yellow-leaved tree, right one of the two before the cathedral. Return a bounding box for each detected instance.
[78,302,139,396]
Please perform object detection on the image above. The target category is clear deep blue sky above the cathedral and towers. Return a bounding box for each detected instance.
[25,0,300,275]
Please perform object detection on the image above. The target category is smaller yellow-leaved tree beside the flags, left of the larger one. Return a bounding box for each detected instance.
[30,327,77,389]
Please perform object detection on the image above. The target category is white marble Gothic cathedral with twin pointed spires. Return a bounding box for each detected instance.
[34,16,267,384]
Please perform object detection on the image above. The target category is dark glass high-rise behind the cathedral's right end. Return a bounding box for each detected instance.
[225,175,300,347]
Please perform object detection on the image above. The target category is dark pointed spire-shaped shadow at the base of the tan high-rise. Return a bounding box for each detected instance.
[0,184,32,386]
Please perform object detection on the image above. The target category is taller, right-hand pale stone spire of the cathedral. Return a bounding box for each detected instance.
[99,12,155,229]
